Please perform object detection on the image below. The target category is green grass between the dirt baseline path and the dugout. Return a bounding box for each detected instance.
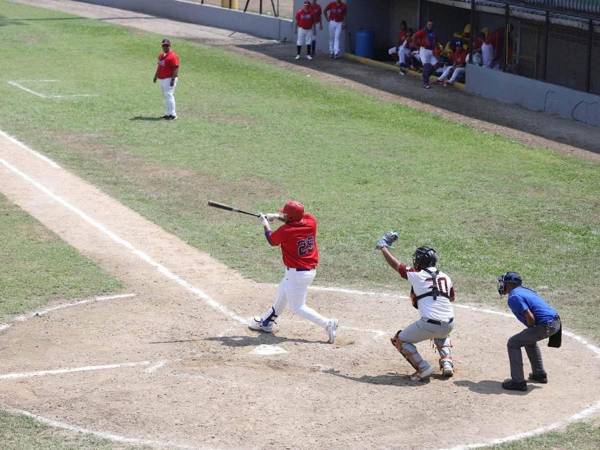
[0,0,600,448]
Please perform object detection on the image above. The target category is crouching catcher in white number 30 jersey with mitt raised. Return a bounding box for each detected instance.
[376,231,454,381]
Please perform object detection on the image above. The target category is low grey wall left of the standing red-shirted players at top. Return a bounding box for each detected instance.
[77,0,295,41]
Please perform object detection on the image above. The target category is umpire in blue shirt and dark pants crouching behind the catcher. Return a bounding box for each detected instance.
[498,272,562,391]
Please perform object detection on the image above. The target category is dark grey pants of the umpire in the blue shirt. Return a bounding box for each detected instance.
[507,318,560,383]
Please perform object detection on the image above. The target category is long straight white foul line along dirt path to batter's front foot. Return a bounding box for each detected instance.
[0,159,248,325]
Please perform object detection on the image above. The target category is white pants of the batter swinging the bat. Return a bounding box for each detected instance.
[261,269,330,328]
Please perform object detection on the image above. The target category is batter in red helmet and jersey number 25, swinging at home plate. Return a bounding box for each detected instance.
[248,200,338,344]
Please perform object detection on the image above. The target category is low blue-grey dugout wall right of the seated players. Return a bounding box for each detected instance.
[465,64,600,127]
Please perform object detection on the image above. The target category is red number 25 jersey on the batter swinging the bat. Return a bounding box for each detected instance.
[267,214,319,269]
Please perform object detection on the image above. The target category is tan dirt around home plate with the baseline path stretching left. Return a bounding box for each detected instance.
[0,132,600,448]
